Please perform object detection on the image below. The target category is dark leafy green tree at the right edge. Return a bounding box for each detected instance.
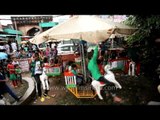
[124,15,160,77]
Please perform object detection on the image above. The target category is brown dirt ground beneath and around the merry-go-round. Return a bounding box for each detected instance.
[25,74,160,105]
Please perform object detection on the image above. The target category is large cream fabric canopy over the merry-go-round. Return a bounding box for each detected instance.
[30,15,114,44]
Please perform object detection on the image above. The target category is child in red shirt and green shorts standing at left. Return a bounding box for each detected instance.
[7,60,17,88]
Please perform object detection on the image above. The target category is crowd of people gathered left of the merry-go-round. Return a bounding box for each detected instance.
[0,40,59,102]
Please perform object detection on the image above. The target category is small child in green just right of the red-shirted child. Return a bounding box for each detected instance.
[15,64,23,84]
